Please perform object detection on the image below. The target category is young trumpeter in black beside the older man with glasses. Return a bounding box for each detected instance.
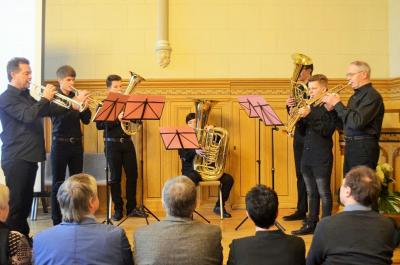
[292,74,338,235]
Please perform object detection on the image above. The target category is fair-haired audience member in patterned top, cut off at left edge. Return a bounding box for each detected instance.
[0,184,32,265]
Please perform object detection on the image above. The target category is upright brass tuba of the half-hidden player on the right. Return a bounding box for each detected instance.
[285,53,313,135]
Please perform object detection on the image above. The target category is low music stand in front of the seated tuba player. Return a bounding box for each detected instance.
[160,126,210,223]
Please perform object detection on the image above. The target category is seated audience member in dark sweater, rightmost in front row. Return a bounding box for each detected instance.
[307,166,397,265]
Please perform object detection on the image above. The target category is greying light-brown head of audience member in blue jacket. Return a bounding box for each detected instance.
[57,173,99,223]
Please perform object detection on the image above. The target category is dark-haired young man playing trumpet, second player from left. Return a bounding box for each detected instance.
[50,65,91,225]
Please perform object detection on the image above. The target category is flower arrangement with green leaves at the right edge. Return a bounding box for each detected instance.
[376,163,400,214]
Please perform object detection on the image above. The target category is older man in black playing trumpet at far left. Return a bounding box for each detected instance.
[0,57,70,236]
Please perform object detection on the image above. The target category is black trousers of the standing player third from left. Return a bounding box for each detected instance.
[104,141,138,212]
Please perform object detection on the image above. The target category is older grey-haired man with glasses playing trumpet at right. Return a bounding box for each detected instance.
[323,61,385,176]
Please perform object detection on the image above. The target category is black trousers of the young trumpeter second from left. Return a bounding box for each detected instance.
[50,141,83,225]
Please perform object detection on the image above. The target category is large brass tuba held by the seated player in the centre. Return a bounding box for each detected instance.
[193,99,228,181]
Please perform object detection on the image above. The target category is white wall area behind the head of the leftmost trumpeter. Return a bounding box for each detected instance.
[0,0,42,183]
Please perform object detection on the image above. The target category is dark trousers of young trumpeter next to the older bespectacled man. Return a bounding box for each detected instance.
[301,163,332,224]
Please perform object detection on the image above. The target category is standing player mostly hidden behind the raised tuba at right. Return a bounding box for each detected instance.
[283,64,314,221]
